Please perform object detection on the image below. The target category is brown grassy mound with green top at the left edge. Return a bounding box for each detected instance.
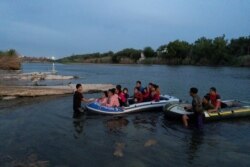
[0,49,21,70]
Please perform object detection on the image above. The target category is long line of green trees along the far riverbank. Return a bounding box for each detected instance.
[58,35,250,66]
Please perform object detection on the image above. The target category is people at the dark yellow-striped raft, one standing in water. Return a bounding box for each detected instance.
[182,87,222,128]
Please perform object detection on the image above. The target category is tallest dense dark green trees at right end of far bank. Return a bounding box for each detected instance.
[157,35,250,66]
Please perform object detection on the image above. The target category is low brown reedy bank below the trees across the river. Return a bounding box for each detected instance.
[56,52,250,67]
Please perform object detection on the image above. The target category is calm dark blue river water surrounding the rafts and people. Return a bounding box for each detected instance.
[0,64,250,167]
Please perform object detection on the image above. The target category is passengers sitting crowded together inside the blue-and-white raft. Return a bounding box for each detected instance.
[97,81,160,107]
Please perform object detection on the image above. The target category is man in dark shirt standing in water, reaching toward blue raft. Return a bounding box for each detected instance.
[73,84,95,114]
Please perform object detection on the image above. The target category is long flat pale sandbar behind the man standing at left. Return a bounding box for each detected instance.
[0,84,115,97]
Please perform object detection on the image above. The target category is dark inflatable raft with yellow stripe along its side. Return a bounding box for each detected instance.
[164,100,250,121]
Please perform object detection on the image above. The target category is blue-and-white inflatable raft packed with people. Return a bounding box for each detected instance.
[86,95,179,115]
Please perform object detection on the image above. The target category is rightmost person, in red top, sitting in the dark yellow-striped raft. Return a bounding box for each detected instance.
[208,87,221,112]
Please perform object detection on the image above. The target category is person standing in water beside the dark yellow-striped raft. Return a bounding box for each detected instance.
[182,88,203,128]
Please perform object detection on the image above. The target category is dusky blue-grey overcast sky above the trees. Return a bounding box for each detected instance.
[0,0,250,58]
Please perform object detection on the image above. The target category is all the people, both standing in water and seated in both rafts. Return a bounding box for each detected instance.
[73,81,221,127]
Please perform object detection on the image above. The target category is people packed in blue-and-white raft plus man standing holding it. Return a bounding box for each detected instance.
[73,81,160,112]
